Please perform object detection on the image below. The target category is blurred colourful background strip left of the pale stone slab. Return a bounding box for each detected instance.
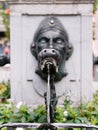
[0,0,10,66]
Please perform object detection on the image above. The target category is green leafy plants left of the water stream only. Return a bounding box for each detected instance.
[0,103,46,124]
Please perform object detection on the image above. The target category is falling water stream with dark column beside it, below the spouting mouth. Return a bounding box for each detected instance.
[44,62,57,130]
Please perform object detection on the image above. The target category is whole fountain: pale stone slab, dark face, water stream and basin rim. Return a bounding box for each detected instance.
[4,0,97,130]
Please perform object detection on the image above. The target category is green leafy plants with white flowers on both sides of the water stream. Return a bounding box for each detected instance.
[0,91,98,125]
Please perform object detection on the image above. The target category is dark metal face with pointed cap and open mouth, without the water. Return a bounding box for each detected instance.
[31,17,73,81]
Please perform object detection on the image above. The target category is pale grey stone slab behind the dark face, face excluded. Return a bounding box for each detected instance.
[10,0,94,105]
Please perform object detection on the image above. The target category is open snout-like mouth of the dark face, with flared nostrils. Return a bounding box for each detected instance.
[38,49,60,74]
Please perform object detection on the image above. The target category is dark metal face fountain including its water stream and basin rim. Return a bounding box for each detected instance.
[0,16,98,130]
